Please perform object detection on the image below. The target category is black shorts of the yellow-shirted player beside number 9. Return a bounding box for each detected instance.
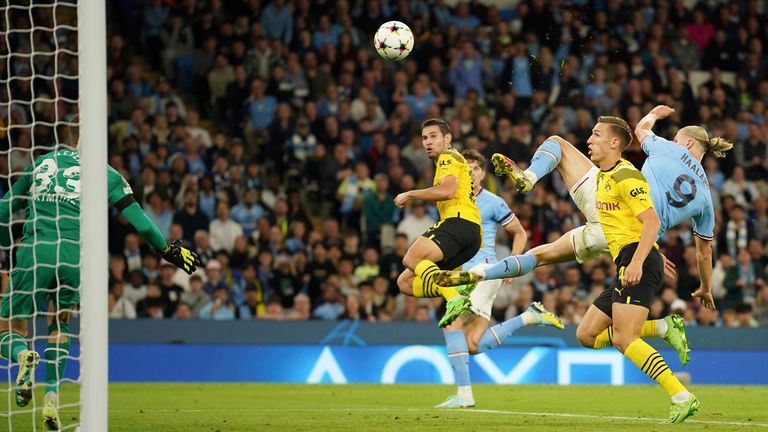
[592,243,664,317]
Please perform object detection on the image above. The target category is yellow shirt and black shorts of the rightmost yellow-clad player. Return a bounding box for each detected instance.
[594,159,664,316]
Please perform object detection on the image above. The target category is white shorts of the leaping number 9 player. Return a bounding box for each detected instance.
[568,167,610,264]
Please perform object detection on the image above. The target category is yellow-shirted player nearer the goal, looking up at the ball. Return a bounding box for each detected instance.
[395,119,482,327]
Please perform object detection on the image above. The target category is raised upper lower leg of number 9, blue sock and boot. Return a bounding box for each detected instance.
[491,138,562,192]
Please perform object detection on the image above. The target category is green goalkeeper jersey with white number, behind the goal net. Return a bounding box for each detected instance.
[0,149,166,250]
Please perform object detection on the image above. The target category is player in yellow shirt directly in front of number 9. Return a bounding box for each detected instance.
[587,116,700,423]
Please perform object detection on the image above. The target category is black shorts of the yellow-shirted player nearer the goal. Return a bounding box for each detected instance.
[422,217,483,270]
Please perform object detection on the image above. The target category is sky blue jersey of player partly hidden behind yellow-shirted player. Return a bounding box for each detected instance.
[462,189,515,270]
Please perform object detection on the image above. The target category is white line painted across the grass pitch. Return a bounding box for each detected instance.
[102,407,768,427]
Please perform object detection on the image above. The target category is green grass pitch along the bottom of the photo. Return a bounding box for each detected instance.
[0,384,768,432]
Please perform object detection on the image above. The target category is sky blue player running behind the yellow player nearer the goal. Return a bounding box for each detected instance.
[436,150,563,408]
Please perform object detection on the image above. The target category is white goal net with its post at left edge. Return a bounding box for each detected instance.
[0,0,107,431]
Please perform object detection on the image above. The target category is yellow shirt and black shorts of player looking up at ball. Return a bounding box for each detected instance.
[423,149,482,270]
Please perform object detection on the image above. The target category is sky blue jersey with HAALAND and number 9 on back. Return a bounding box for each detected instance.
[642,134,715,240]
